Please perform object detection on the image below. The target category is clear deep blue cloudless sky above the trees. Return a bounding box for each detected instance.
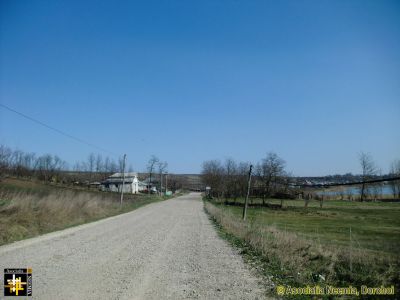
[0,0,400,176]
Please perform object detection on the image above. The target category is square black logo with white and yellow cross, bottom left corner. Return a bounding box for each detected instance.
[4,268,32,296]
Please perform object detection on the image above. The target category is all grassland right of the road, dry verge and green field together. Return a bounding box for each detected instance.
[205,199,400,296]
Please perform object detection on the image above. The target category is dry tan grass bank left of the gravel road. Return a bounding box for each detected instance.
[0,189,158,245]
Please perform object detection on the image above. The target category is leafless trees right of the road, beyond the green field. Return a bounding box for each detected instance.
[202,152,400,204]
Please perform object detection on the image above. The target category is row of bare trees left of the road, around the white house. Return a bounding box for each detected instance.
[0,145,181,192]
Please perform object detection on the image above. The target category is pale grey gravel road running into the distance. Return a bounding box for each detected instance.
[0,193,264,299]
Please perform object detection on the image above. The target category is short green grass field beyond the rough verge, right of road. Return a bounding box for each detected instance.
[214,199,400,255]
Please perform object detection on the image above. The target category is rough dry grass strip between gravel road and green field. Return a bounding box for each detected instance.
[205,202,400,286]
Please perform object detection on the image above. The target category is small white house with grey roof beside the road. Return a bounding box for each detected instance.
[101,172,139,194]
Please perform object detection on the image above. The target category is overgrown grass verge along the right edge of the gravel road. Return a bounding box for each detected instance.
[204,201,399,299]
